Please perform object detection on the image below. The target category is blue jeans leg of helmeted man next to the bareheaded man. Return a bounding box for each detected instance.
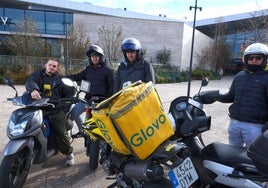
[71,103,85,132]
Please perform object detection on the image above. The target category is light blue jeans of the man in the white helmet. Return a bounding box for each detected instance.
[228,119,263,148]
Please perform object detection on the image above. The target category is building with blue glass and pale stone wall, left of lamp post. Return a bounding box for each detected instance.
[0,0,212,70]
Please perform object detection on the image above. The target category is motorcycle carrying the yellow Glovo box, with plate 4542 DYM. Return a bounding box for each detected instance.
[93,82,202,188]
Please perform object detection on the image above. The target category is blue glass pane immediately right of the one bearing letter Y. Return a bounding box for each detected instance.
[26,10,46,34]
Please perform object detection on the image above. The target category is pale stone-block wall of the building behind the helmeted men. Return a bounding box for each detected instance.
[74,14,211,70]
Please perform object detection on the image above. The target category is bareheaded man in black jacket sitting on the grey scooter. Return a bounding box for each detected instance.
[25,59,74,165]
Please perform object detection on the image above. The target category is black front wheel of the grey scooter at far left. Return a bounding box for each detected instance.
[0,149,32,188]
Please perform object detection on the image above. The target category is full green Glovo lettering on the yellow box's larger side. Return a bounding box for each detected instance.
[129,114,166,147]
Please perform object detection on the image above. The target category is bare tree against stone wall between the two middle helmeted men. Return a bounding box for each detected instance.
[98,25,123,64]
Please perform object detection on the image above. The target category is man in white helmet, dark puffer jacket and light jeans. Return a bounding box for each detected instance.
[201,43,268,147]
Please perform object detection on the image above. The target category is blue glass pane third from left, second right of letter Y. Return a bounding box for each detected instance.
[46,12,65,35]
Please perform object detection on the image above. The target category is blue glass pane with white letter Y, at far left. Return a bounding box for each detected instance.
[4,8,24,31]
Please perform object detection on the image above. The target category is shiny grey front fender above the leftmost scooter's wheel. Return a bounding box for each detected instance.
[3,137,34,156]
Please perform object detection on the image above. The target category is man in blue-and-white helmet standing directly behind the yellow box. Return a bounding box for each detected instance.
[115,38,155,92]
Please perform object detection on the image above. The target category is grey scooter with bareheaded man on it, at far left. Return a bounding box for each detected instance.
[0,78,76,187]
